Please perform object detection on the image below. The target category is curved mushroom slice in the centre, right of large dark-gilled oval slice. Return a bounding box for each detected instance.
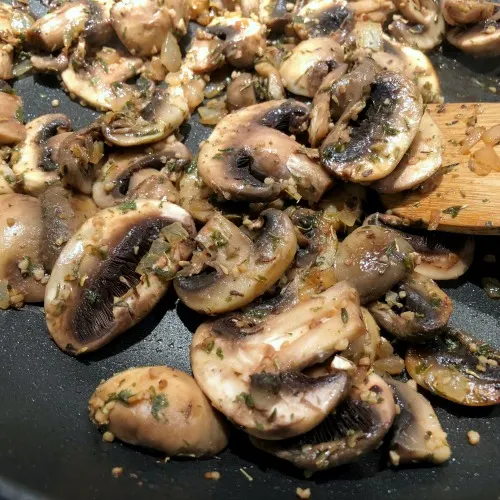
[174,209,297,314]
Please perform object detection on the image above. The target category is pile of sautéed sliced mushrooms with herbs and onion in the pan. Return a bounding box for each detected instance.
[0,0,500,472]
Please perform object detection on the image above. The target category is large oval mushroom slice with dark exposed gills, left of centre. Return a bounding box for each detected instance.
[45,200,195,355]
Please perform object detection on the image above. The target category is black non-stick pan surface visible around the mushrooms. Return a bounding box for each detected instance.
[0,4,500,500]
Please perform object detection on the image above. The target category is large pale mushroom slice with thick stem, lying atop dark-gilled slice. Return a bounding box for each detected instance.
[191,283,364,439]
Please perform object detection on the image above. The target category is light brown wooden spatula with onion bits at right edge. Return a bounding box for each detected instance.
[382,102,500,234]
